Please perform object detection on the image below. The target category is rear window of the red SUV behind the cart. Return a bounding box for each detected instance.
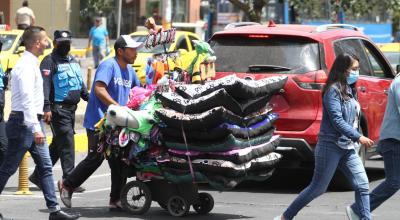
[210,35,321,74]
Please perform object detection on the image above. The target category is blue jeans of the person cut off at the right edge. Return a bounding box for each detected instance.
[351,139,400,215]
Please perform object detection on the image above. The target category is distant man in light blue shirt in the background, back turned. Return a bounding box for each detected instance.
[88,17,110,68]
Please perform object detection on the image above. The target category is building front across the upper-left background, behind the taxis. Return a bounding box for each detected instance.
[0,0,201,38]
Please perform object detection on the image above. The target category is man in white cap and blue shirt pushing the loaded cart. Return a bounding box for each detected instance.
[58,35,142,211]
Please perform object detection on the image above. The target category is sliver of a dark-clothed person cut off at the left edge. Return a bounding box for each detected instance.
[0,42,8,165]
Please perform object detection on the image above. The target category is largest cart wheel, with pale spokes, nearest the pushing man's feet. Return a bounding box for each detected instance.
[121,181,151,215]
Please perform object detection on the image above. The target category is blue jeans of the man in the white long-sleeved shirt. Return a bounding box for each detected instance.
[0,111,60,212]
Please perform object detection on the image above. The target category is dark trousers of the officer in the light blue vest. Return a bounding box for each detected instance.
[33,108,75,178]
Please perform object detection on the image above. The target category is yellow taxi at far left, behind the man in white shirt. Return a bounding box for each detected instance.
[0,30,53,72]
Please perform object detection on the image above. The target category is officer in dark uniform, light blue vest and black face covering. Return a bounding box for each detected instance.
[29,30,89,192]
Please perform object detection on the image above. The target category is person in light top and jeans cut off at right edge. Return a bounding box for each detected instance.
[346,75,400,220]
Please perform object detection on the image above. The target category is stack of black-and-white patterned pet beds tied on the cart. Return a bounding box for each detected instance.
[155,75,287,189]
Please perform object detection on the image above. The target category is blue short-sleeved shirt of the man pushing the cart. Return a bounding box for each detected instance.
[83,58,140,130]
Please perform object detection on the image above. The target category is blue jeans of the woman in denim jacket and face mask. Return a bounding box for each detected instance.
[283,141,371,220]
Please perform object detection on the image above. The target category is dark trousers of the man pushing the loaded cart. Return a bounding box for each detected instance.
[64,129,126,202]
